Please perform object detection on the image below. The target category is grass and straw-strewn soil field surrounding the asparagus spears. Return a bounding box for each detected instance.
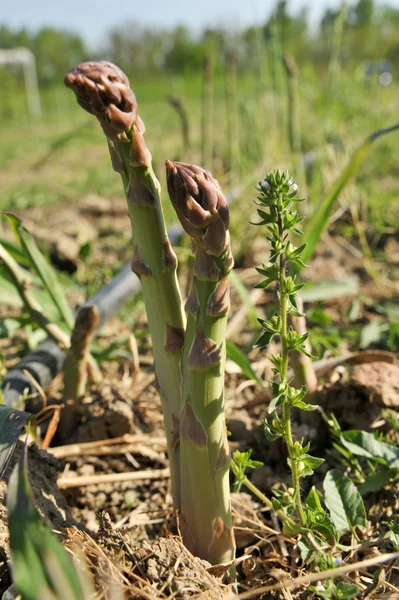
[0,54,399,599]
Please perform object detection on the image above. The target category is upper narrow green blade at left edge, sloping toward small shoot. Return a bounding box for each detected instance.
[4,213,74,329]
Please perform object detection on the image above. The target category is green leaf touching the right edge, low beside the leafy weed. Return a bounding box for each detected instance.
[341,429,399,469]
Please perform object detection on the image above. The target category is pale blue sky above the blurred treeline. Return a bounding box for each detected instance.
[0,0,399,48]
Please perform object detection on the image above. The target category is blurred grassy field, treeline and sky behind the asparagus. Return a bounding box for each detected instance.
[0,0,399,286]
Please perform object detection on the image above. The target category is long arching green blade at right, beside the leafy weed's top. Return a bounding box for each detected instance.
[304,123,399,271]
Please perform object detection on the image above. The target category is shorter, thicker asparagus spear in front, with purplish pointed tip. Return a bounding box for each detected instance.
[166,161,235,564]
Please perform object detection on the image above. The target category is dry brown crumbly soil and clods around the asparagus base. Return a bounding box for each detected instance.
[0,198,399,600]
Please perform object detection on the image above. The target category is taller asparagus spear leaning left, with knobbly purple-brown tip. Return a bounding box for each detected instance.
[65,61,185,507]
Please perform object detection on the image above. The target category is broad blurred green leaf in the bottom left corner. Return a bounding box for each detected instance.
[7,460,84,600]
